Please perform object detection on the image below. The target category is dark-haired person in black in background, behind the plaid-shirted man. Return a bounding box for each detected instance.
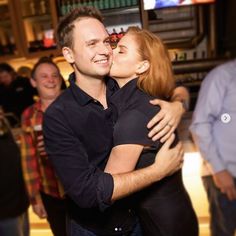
[0,63,37,125]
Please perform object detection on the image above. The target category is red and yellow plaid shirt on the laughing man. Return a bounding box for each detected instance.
[20,100,62,204]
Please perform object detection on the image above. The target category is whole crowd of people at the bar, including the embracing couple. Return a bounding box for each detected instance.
[0,4,236,236]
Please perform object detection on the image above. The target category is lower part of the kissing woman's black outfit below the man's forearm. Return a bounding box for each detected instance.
[137,171,198,236]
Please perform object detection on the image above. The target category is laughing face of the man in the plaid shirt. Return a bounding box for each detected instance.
[31,63,62,99]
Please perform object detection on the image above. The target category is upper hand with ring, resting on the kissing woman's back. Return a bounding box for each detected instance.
[147,99,185,142]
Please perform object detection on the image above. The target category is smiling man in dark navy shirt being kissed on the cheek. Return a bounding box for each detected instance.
[44,7,189,236]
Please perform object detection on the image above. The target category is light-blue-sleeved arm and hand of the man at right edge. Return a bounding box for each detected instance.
[190,69,236,200]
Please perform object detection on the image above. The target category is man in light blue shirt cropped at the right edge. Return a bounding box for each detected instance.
[190,60,236,236]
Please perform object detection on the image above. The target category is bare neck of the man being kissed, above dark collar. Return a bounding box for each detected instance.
[76,75,107,108]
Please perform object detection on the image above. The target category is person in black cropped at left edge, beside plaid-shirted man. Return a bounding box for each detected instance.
[0,109,29,236]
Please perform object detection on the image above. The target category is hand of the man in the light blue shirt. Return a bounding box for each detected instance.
[213,170,236,200]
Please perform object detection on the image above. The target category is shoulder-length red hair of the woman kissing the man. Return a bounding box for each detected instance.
[126,27,175,99]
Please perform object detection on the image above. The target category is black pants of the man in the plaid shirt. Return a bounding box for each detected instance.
[41,192,66,236]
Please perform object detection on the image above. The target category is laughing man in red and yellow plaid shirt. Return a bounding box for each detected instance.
[21,58,66,236]
